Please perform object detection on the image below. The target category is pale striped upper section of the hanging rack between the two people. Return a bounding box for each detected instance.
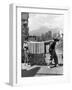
[27,40,53,54]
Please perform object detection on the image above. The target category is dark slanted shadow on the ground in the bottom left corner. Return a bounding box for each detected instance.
[21,67,40,77]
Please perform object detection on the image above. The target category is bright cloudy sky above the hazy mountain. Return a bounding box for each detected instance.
[29,13,64,31]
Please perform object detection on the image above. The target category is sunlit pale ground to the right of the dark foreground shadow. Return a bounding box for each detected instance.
[37,66,63,75]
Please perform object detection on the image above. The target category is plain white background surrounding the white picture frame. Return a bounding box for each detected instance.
[0,0,72,90]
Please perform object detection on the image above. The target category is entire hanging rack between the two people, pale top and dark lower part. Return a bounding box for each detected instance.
[27,40,52,65]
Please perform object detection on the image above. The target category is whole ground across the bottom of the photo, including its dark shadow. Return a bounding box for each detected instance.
[22,65,63,77]
